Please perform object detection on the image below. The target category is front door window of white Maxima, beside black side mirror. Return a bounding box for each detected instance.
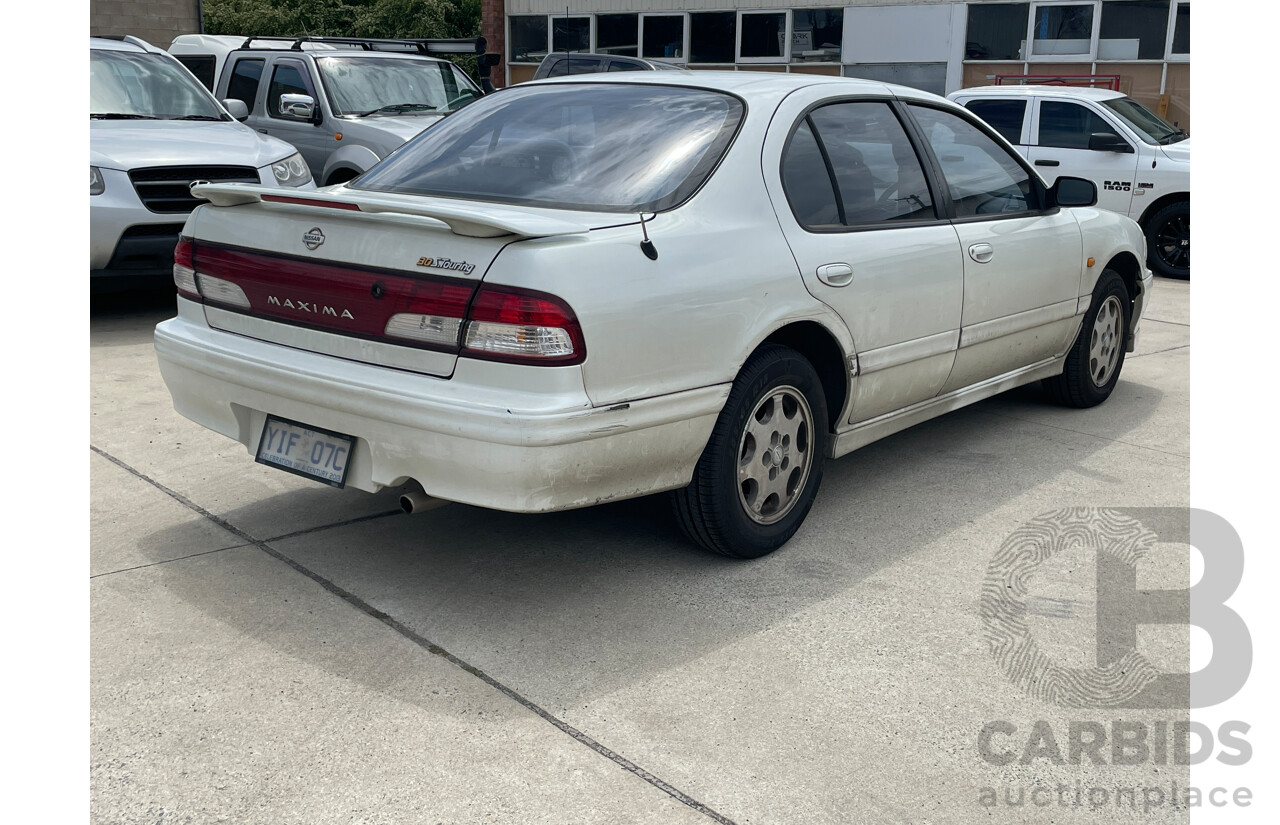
[911,105,1041,217]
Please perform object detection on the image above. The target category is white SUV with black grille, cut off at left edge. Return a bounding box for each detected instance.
[88,37,315,292]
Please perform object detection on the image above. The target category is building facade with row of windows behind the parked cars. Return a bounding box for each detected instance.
[481,0,1190,129]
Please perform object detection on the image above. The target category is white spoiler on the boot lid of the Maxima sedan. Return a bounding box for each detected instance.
[191,183,591,238]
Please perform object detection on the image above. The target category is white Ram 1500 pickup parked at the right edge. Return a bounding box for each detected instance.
[948,86,1192,278]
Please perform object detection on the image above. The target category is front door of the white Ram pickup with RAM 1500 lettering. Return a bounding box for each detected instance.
[1027,96,1138,215]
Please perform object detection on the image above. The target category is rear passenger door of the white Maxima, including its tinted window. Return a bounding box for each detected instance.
[764,87,964,422]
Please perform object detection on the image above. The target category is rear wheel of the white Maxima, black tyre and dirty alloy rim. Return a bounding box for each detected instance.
[671,344,827,559]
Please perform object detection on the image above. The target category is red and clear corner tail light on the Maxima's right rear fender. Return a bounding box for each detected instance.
[462,287,586,366]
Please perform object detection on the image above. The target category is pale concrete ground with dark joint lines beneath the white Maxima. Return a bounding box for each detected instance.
[90,280,1190,825]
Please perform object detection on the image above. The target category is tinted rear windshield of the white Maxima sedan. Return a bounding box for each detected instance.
[352,83,744,212]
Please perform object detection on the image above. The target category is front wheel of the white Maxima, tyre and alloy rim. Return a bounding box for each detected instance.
[1044,270,1132,408]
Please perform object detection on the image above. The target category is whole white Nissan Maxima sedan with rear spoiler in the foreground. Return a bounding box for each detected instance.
[155,72,1151,558]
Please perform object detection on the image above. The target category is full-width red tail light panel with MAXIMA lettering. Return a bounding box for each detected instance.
[173,238,586,366]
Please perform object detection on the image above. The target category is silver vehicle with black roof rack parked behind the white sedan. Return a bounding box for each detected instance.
[169,35,485,185]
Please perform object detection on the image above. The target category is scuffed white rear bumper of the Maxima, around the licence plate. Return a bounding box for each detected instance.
[155,299,730,513]
